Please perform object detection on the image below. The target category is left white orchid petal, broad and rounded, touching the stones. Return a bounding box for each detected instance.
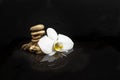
[38,36,54,54]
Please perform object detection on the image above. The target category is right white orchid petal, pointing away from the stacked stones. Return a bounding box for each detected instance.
[58,34,74,52]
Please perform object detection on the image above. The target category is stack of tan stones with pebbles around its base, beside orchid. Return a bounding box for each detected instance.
[22,24,45,54]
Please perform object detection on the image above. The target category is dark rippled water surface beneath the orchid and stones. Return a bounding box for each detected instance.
[0,41,120,80]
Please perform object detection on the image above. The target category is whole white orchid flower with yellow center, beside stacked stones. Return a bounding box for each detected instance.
[38,28,74,56]
